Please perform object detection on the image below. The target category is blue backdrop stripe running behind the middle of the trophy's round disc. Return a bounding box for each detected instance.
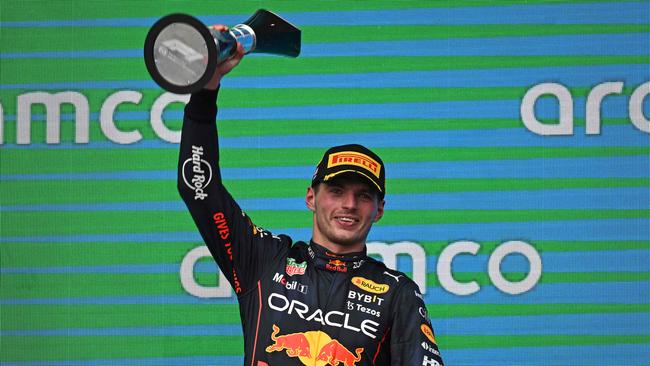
[0,33,650,59]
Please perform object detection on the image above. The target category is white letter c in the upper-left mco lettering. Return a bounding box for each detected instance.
[99,90,142,144]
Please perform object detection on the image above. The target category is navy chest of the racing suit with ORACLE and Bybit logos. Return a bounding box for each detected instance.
[261,261,392,362]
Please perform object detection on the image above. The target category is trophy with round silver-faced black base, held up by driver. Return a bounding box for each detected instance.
[144,9,300,94]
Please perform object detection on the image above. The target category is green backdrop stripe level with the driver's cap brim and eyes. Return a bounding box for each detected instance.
[0,179,650,206]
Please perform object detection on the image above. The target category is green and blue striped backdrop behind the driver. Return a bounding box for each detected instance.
[0,0,650,366]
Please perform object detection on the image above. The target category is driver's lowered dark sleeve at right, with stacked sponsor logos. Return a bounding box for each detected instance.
[390,281,444,366]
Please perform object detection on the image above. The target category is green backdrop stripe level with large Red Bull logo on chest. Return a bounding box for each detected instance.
[1,335,650,362]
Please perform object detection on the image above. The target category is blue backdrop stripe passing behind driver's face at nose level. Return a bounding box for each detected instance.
[0,187,650,212]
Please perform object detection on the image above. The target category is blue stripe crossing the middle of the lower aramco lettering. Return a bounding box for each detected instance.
[0,249,650,274]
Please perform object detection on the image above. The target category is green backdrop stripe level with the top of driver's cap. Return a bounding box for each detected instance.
[0,144,650,174]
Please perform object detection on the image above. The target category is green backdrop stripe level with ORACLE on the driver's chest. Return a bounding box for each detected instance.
[2,304,650,332]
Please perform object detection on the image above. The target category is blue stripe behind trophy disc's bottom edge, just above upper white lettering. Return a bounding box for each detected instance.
[0,64,650,90]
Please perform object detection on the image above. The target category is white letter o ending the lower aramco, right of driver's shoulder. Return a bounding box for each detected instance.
[488,240,542,295]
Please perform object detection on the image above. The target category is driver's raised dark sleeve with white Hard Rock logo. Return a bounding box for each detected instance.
[178,90,289,295]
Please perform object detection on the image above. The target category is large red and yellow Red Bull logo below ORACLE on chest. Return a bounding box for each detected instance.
[266,324,363,366]
